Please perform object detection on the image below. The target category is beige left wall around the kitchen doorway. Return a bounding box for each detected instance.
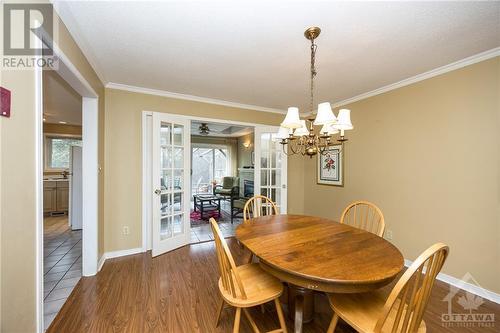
[0,6,104,333]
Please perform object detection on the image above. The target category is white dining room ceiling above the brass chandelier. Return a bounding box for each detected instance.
[56,1,500,110]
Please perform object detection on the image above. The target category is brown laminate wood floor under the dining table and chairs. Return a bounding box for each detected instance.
[48,239,500,333]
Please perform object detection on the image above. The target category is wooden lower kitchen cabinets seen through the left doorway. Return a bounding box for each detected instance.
[43,180,69,213]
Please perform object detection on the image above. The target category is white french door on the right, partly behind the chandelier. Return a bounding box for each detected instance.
[254,126,287,214]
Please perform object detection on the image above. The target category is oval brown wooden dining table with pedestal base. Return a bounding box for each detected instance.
[236,215,404,332]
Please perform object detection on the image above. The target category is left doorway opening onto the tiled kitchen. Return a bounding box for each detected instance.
[42,71,83,329]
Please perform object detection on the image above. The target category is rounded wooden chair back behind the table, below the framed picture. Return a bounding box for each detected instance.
[340,201,385,237]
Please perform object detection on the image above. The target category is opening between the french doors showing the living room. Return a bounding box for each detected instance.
[190,120,255,244]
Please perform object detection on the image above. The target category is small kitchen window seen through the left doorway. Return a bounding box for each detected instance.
[45,135,82,170]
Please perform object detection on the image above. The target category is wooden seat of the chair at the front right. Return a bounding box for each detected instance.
[328,290,426,333]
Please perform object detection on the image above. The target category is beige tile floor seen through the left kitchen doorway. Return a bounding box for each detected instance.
[43,215,82,329]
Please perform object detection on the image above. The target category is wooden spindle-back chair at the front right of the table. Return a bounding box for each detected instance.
[328,243,449,333]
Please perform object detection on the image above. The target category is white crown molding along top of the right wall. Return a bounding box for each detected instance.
[332,47,500,108]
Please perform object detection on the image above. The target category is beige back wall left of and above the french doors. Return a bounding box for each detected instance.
[104,89,300,252]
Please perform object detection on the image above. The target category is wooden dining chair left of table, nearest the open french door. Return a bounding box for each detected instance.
[210,218,286,333]
